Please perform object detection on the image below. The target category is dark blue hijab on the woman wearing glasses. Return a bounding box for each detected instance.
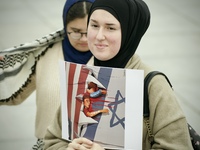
[62,0,94,64]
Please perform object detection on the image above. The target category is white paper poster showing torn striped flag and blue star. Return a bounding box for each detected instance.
[60,61,144,150]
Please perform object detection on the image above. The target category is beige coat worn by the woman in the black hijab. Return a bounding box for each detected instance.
[45,54,193,150]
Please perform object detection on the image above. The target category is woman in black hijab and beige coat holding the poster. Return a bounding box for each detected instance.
[45,0,192,150]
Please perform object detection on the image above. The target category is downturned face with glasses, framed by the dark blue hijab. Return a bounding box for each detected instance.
[66,16,89,52]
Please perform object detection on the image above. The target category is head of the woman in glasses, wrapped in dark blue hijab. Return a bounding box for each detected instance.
[62,0,94,64]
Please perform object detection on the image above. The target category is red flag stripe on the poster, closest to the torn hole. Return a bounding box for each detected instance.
[74,66,89,137]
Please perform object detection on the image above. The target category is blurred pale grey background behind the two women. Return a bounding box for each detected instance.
[0,0,200,150]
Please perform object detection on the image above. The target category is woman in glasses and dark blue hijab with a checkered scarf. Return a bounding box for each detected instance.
[0,0,93,149]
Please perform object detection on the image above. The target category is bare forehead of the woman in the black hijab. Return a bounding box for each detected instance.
[90,9,119,24]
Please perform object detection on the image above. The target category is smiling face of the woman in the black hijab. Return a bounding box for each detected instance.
[87,9,121,61]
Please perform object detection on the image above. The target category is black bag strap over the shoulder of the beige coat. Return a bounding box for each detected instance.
[143,71,172,117]
